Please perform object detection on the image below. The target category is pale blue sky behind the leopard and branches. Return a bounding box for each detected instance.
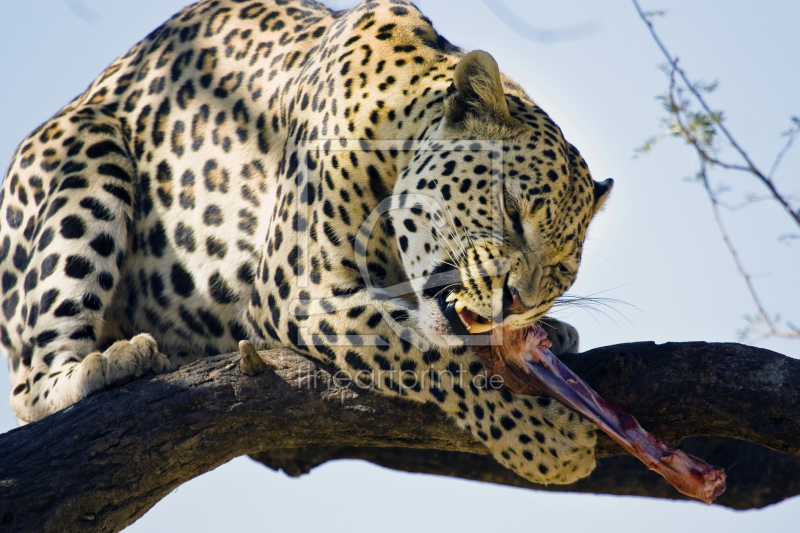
[0,0,800,532]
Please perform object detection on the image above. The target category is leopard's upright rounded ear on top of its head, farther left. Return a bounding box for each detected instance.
[444,50,511,128]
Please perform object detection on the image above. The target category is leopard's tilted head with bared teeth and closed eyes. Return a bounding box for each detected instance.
[391,51,613,343]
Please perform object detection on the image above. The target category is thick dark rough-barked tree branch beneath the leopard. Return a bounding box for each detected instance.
[0,343,800,532]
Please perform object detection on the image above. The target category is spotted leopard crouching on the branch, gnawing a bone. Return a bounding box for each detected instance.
[0,0,613,484]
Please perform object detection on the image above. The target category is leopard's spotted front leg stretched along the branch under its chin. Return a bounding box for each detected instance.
[249,291,595,484]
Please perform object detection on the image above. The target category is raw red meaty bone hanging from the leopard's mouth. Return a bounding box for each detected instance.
[479,326,725,505]
